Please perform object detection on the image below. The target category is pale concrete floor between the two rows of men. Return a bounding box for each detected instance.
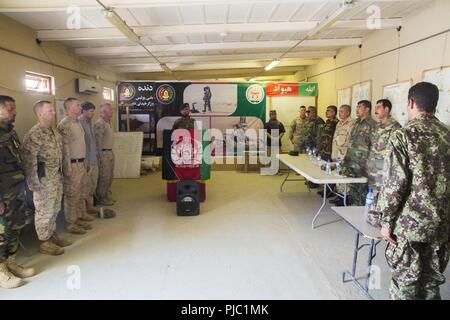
[0,171,450,300]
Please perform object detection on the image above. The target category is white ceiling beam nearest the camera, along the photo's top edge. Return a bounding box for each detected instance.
[0,0,431,12]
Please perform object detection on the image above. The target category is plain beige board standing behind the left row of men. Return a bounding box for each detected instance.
[113,132,144,178]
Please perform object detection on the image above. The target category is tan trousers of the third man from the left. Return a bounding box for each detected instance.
[64,162,87,224]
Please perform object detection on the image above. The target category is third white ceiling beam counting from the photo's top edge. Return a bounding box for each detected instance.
[75,38,362,58]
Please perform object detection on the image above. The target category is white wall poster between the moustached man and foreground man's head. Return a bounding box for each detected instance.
[383,81,411,126]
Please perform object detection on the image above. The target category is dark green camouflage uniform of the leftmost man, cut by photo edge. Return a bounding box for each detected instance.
[0,122,26,263]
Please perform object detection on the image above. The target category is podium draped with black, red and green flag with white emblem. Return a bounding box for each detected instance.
[162,129,211,202]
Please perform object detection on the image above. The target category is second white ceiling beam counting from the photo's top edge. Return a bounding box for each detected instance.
[37,18,402,41]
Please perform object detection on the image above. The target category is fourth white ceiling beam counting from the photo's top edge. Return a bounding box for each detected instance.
[99,51,337,66]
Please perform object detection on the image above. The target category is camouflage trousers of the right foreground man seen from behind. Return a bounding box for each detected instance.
[385,240,449,300]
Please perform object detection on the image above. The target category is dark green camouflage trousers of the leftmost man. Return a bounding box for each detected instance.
[0,197,25,263]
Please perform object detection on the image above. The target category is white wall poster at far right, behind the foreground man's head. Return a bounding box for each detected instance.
[423,66,450,126]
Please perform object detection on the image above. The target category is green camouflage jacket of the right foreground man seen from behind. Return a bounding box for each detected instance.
[375,115,450,242]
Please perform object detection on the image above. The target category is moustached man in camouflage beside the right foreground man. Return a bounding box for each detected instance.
[367,99,401,226]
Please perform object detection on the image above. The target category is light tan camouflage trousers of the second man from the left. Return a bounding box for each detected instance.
[33,175,63,241]
